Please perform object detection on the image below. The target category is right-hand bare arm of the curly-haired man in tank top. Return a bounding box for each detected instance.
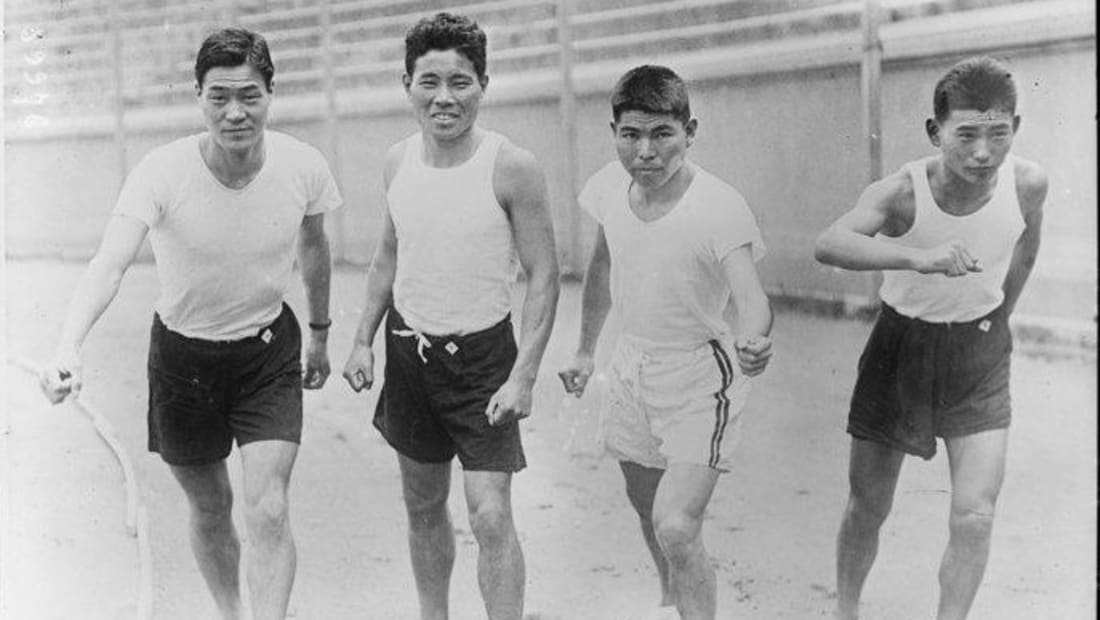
[485,144,558,424]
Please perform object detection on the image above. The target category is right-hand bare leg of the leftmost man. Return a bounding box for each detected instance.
[241,441,298,620]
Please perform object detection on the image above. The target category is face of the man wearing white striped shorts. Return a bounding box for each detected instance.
[612,110,697,188]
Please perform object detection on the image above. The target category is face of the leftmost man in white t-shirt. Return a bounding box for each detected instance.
[196,64,272,152]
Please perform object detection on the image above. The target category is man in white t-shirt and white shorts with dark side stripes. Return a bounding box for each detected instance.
[560,65,772,620]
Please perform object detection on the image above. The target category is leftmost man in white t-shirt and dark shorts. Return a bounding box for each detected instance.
[42,29,341,620]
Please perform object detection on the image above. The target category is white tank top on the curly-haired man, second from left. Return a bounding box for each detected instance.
[386,131,517,335]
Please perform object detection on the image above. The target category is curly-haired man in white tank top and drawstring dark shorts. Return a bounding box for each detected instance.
[343,13,558,620]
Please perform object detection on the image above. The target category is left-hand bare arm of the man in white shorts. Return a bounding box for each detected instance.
[558,225,612,398]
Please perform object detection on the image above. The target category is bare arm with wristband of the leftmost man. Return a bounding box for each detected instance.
[298,213,332,389]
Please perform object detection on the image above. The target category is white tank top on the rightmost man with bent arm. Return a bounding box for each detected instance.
[879,155,1024,323]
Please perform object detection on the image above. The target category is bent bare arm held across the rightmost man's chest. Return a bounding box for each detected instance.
[814,171,981,276]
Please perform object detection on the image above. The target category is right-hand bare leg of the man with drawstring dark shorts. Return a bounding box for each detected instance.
[464,472,527,620]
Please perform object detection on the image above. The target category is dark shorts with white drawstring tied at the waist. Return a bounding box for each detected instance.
[374,308,527,472]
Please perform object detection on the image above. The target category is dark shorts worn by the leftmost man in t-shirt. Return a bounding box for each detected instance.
[149,303,301,465]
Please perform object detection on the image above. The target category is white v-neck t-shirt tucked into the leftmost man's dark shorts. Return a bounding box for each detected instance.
[114,131,342,341]
